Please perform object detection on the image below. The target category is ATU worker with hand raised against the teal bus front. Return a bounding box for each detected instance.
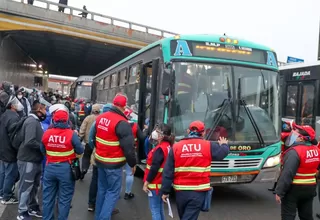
[161,121,229,220]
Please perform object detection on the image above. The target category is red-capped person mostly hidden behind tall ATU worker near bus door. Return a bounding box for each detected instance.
[124,108,146,200]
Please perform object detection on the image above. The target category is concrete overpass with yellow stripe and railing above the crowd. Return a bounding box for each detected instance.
[0,0,175,80]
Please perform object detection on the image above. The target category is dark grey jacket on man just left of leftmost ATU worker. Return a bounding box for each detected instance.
[18,114,43,163]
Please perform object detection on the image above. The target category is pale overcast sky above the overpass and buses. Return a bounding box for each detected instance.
[47,0,320,62]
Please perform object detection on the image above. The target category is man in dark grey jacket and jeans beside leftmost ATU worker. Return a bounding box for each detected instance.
[17,101,46,220]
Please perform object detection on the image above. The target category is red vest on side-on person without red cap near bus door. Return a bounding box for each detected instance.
[143,141,170,192]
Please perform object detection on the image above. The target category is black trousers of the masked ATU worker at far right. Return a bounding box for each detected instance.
[281,185,317,220]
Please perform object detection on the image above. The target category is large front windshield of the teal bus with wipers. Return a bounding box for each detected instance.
[171,62,280,143]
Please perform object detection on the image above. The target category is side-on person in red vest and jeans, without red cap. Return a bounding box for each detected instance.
[143,124,171,220]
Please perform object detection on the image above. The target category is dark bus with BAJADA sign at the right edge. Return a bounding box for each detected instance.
[279,61,320,129]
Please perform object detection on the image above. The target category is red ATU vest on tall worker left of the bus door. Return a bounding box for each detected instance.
[95,111,126,164]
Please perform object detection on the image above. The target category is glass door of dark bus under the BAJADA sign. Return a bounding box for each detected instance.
[283,81,318,127]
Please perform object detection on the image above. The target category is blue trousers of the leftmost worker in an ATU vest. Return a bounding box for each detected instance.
[43,163,75,220]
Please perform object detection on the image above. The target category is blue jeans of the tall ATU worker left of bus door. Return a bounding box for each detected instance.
[95,167,122,220]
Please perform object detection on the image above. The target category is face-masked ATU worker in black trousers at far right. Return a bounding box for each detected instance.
[275,125,320,220]
